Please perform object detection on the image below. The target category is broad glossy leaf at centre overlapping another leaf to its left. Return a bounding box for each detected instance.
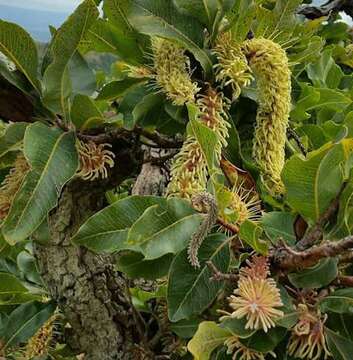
[127,198,203,260]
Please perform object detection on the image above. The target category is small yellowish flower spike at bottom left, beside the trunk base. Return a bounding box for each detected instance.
[24,316,56,360]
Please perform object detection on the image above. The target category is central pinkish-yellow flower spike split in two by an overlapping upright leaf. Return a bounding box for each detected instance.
[167,88,228,198]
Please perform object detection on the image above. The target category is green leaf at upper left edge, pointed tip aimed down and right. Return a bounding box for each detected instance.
[0,20,40,92]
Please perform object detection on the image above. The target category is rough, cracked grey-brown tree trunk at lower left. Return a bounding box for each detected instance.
[36,184,138,360]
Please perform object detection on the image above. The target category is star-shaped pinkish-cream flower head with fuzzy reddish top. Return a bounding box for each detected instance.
[228,257,284,332]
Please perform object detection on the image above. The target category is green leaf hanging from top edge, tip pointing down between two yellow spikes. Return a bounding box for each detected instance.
[127,0,212,75]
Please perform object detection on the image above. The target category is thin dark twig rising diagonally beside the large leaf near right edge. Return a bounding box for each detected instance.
[296,183,346,250]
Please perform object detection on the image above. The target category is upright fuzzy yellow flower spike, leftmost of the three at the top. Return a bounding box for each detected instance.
[152,37,199,105]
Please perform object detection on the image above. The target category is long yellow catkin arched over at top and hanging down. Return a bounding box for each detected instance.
[243,38,291,195]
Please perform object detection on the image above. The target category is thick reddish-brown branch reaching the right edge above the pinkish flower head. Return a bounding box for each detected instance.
[272,236,353,271]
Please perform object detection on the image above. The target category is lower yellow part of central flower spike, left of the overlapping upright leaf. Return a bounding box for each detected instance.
[167,136,207,199]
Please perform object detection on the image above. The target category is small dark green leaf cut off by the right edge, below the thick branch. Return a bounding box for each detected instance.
[320,288,353,314]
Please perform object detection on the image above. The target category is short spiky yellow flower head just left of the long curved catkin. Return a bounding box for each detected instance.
[213,32,253,100]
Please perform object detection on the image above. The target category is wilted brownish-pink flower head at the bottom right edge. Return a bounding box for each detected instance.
[288,304,332,360]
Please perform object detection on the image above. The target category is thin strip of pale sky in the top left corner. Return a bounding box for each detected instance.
[0,0,82,12]
